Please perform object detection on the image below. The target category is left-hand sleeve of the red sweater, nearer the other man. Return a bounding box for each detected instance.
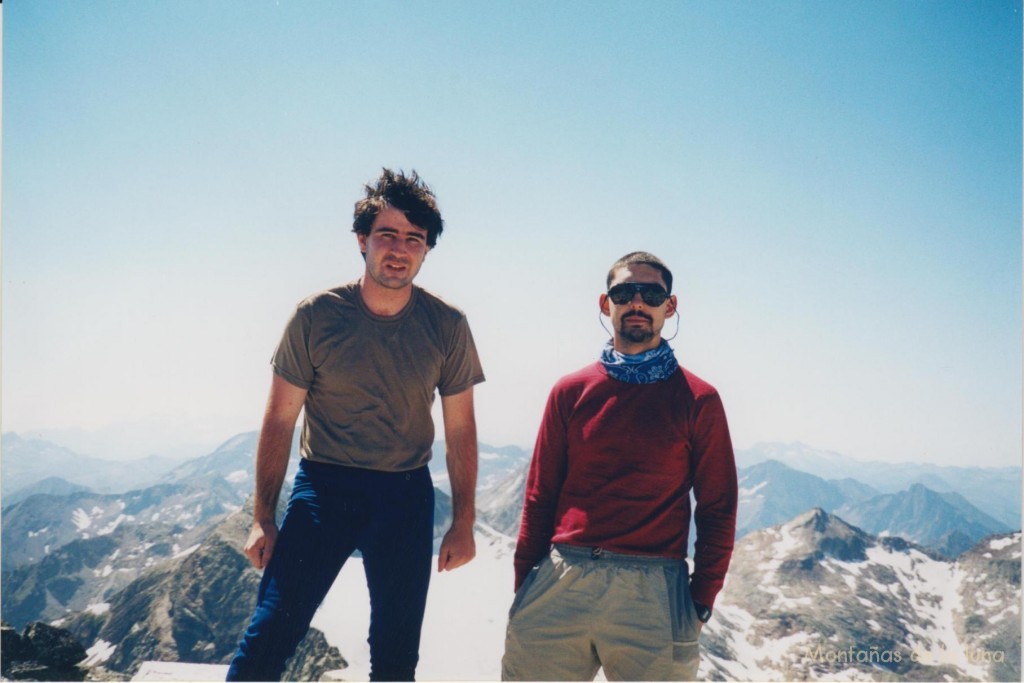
[515,386,566,590]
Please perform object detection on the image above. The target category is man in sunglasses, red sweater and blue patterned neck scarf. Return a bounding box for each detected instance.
[502,252,737,681]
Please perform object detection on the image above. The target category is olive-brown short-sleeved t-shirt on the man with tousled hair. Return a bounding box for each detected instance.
[271,282,483,472]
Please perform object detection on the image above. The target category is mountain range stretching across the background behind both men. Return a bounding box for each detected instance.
[0,432,1020,680]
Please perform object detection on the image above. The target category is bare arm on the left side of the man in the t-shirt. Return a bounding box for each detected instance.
[245,374,306,569]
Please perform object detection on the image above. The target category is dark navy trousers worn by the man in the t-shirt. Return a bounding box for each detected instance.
[227,460,434,681]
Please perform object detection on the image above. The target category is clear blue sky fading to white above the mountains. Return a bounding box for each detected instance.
[2,0,1022,465]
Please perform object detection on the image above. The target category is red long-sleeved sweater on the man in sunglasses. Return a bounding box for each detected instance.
[515,362,737,607]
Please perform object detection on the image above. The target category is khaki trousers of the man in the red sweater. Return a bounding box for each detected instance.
[502,545,701,681]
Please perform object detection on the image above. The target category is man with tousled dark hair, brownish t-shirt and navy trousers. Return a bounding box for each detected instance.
[227,169,483,681]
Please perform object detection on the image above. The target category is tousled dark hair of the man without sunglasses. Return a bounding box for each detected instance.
[352,168,444,247]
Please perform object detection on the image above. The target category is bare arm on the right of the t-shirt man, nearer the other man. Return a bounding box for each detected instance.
[437,387,477,571]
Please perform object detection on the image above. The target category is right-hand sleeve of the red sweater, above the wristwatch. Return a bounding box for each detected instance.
[690,393,738,607]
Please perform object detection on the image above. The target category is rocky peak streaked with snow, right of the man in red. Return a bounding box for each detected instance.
[702,509,1021,681]
